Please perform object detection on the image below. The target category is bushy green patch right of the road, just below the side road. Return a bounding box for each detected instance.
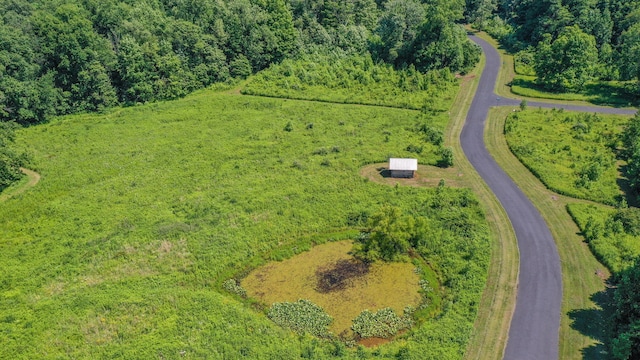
[504,109,629,205]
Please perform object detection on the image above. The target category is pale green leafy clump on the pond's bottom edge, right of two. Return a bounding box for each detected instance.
[351,307,413,338]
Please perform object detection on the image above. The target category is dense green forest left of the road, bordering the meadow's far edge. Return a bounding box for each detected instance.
[0,0,479,125]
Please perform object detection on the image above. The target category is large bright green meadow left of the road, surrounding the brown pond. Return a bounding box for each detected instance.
[0,91,489,359]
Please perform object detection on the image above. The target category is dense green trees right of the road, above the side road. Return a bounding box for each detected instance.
[465,0,640,96]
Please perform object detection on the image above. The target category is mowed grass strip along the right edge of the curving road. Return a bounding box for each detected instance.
[485,108,609,359]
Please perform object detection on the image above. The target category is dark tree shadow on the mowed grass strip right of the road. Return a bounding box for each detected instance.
[568,287,613,360]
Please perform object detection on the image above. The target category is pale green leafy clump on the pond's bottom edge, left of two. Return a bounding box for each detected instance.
[267,299,333,337]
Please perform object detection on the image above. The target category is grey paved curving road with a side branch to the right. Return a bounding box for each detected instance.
[460,36,635,360]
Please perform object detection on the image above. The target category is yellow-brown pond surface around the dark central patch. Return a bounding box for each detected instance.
[242,241,439,336]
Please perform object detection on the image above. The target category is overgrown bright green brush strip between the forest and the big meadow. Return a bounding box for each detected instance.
[242,55,458,113]
